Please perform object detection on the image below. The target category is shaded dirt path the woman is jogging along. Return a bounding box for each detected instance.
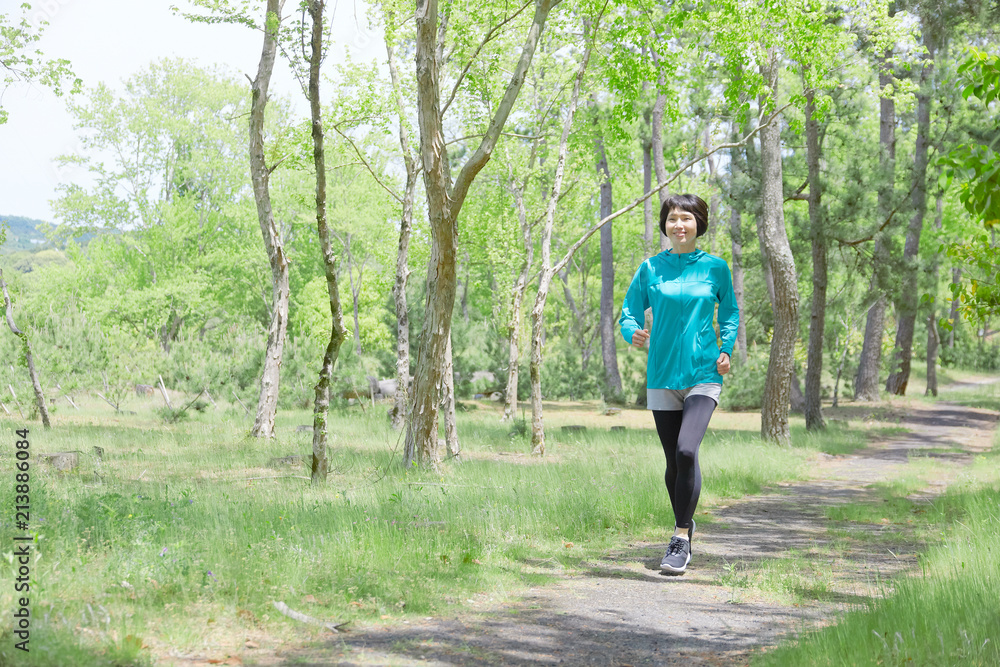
[267,404,998,666]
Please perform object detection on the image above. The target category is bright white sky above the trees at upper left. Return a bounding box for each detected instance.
[0,0,385,222]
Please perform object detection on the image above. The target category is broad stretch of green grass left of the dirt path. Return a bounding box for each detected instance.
[0,400,864,667]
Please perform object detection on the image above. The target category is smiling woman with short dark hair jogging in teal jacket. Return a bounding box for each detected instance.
[618,194,740,574]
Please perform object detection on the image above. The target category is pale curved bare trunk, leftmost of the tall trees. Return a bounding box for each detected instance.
[250,0,289,438]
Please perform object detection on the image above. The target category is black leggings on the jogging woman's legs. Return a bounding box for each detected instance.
[653,396,715,528]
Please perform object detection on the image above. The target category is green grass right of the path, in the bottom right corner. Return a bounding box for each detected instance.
[753,384,1000,667]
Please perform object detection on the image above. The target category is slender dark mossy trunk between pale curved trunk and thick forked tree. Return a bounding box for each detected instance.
[308,0,347,485]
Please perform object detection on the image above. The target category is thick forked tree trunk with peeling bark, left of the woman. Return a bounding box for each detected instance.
[403,0,557,468]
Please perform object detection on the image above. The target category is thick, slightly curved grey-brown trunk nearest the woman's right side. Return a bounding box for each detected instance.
[760,48,799,444]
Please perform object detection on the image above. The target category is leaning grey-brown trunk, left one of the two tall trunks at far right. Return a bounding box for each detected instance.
[854,40,896,401]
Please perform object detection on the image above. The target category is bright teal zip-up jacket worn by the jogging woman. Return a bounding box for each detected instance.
[618,250,740,389]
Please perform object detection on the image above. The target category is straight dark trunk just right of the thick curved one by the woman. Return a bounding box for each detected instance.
[805,90,827,431]
